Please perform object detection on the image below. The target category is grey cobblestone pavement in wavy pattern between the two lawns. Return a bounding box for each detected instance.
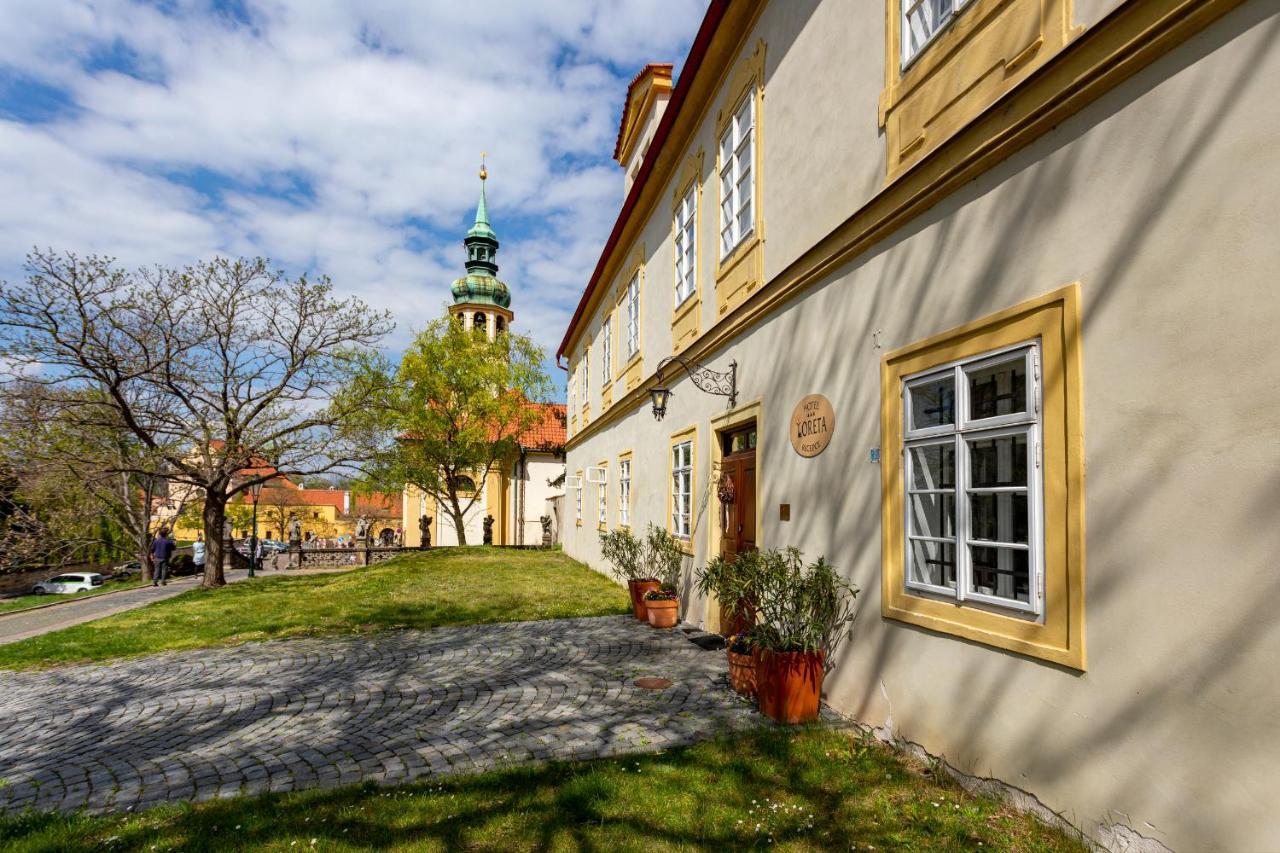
[0,616,760,811]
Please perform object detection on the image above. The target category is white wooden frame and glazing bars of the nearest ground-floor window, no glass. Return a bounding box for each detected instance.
[900,341,1044,619]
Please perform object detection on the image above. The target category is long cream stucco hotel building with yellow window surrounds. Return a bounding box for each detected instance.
[559,0,1280,850]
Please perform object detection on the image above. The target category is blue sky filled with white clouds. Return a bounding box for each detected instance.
[0,0,705,393]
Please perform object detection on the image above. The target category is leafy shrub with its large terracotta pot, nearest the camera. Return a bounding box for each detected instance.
[751,548,858,725]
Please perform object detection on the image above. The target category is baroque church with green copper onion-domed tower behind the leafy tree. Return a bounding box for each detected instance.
[401,168,564,547]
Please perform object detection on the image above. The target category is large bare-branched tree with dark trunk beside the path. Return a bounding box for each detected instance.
[0,251,392,587]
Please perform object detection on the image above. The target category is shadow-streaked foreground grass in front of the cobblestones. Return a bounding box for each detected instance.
[0,727,1088,853]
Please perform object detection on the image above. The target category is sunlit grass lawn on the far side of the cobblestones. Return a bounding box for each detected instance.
[0,547,630,669]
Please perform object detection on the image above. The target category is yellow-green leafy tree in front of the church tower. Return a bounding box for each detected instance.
[343,319,550,544]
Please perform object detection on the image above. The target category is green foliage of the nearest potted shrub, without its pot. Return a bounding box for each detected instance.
[744,548,858,667]
